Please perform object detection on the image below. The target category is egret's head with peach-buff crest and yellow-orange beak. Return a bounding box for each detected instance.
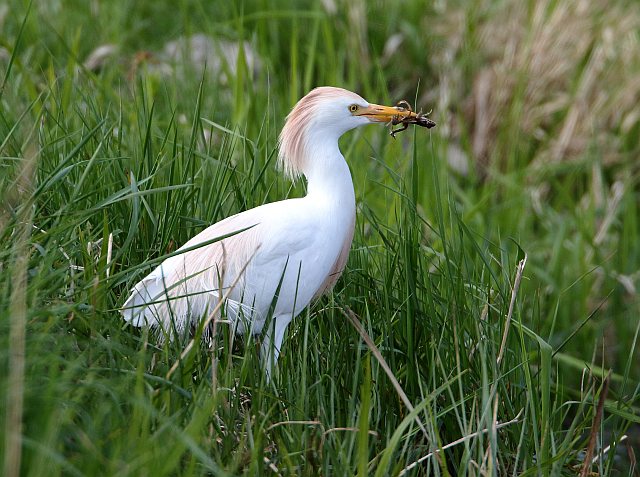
[278,86,424,178]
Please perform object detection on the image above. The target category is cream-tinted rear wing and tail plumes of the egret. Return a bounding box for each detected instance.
[122,208,262,332]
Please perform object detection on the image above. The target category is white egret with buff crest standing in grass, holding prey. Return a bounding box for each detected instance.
[122,87,434,378]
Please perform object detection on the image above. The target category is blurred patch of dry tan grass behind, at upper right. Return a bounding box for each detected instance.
[430,0,640,174]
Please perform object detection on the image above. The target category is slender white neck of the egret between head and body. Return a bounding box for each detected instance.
[304,140,355,205]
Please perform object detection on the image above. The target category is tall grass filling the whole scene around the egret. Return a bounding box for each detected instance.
[0,0,640,476]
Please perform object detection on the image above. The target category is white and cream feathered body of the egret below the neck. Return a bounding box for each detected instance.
[122,199,344,332]
